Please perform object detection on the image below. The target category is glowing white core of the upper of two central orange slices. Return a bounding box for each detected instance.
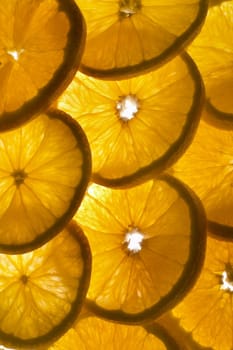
[116,95,138,121]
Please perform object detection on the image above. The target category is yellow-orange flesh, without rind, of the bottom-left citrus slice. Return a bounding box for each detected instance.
[0,230,84,340]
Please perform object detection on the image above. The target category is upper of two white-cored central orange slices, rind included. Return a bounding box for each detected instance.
[58,54,204,187]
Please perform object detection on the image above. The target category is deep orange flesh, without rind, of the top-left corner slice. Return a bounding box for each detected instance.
[0,0,70,115]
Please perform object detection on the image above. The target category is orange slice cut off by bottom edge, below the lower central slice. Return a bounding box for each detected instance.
[49,316,180,350]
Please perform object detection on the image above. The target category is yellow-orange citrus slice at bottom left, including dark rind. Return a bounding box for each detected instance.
[0,222,91,349]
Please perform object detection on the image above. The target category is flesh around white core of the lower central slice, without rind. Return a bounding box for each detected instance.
[75,181,191,314]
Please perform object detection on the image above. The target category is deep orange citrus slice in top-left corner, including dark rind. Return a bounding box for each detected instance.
[0,0,86,131]
